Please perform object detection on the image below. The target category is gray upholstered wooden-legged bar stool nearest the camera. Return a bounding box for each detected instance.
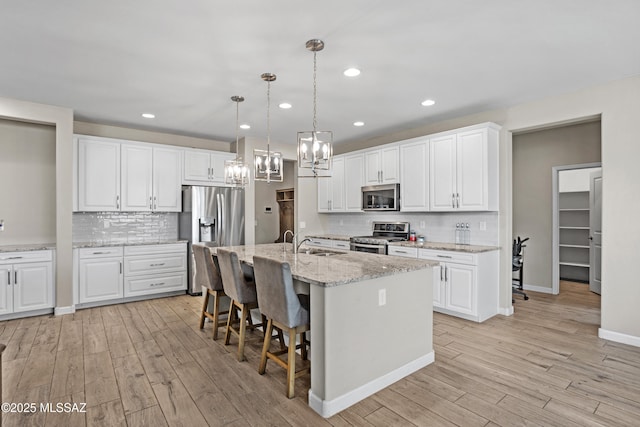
[253,256,310,399]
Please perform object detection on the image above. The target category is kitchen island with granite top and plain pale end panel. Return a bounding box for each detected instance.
[212,243,437,417]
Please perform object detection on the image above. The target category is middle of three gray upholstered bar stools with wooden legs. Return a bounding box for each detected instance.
[217,249,263,361]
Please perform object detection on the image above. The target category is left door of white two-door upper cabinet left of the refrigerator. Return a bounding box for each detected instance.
[120,144,153,212]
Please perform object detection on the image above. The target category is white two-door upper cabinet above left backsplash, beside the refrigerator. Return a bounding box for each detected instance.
[121,144,182,212]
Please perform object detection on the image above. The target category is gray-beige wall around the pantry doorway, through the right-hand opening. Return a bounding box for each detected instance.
[513,121,601,290]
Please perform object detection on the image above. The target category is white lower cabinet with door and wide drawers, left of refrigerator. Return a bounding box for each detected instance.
[78,243,187,305]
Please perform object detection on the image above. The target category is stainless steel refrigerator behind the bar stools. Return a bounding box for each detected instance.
[178,186,244,295]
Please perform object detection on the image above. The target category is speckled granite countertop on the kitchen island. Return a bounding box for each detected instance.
[210,243,438,287]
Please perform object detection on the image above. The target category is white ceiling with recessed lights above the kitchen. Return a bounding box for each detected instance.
[0,0,640,144]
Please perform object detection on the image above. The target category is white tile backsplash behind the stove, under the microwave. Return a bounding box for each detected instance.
[327,212,500,246]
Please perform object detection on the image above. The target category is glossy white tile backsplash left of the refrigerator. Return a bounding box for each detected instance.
[73,212,178,243]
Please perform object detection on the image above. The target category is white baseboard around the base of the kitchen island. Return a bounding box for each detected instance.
[309,351,435,418]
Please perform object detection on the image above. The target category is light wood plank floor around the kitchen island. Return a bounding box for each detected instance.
[0,283,640,427]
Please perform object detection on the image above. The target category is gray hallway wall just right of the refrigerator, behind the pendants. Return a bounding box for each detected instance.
[255,160,296,244]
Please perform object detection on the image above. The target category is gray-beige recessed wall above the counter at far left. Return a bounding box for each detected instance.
[0,119,56,245]
